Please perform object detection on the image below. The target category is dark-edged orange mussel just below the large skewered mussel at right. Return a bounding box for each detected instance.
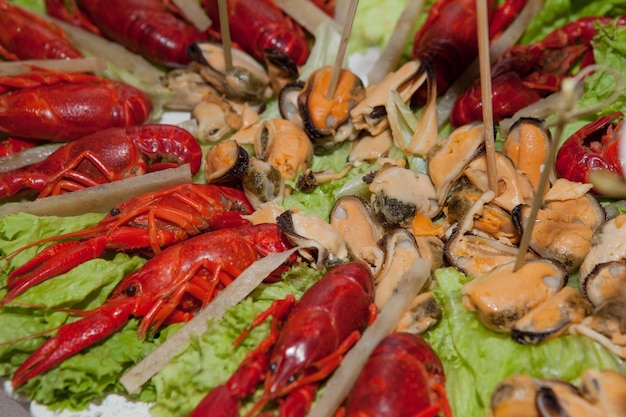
[511,286,593,344]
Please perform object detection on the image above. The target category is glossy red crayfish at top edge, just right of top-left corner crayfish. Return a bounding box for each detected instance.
[46,0,206,66]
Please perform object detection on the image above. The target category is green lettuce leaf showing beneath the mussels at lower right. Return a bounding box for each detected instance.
[424,268,626,417]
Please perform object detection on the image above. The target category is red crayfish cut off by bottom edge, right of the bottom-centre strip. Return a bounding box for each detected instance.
[336,333,452,417]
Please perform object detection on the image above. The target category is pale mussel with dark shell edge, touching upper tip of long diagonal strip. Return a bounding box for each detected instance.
[276,210,348,267]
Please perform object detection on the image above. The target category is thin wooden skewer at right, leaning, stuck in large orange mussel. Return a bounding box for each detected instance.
[513,78,576,272]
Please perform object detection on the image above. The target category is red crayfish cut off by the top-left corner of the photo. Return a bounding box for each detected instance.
[0,0,83,61]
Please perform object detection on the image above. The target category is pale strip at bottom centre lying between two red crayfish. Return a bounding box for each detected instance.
[308,259,430,417]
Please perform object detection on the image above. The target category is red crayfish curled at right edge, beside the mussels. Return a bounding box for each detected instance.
[554,112,626,187]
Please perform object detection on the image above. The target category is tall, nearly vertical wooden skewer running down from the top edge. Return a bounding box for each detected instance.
[476,0,498,196]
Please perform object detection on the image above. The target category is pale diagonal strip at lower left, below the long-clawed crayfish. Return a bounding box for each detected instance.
[120,247,298,394]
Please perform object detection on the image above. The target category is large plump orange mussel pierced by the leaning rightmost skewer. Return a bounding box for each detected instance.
[461,259,568,333]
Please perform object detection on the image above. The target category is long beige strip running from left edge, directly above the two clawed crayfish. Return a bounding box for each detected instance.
[0,164,191,216]
